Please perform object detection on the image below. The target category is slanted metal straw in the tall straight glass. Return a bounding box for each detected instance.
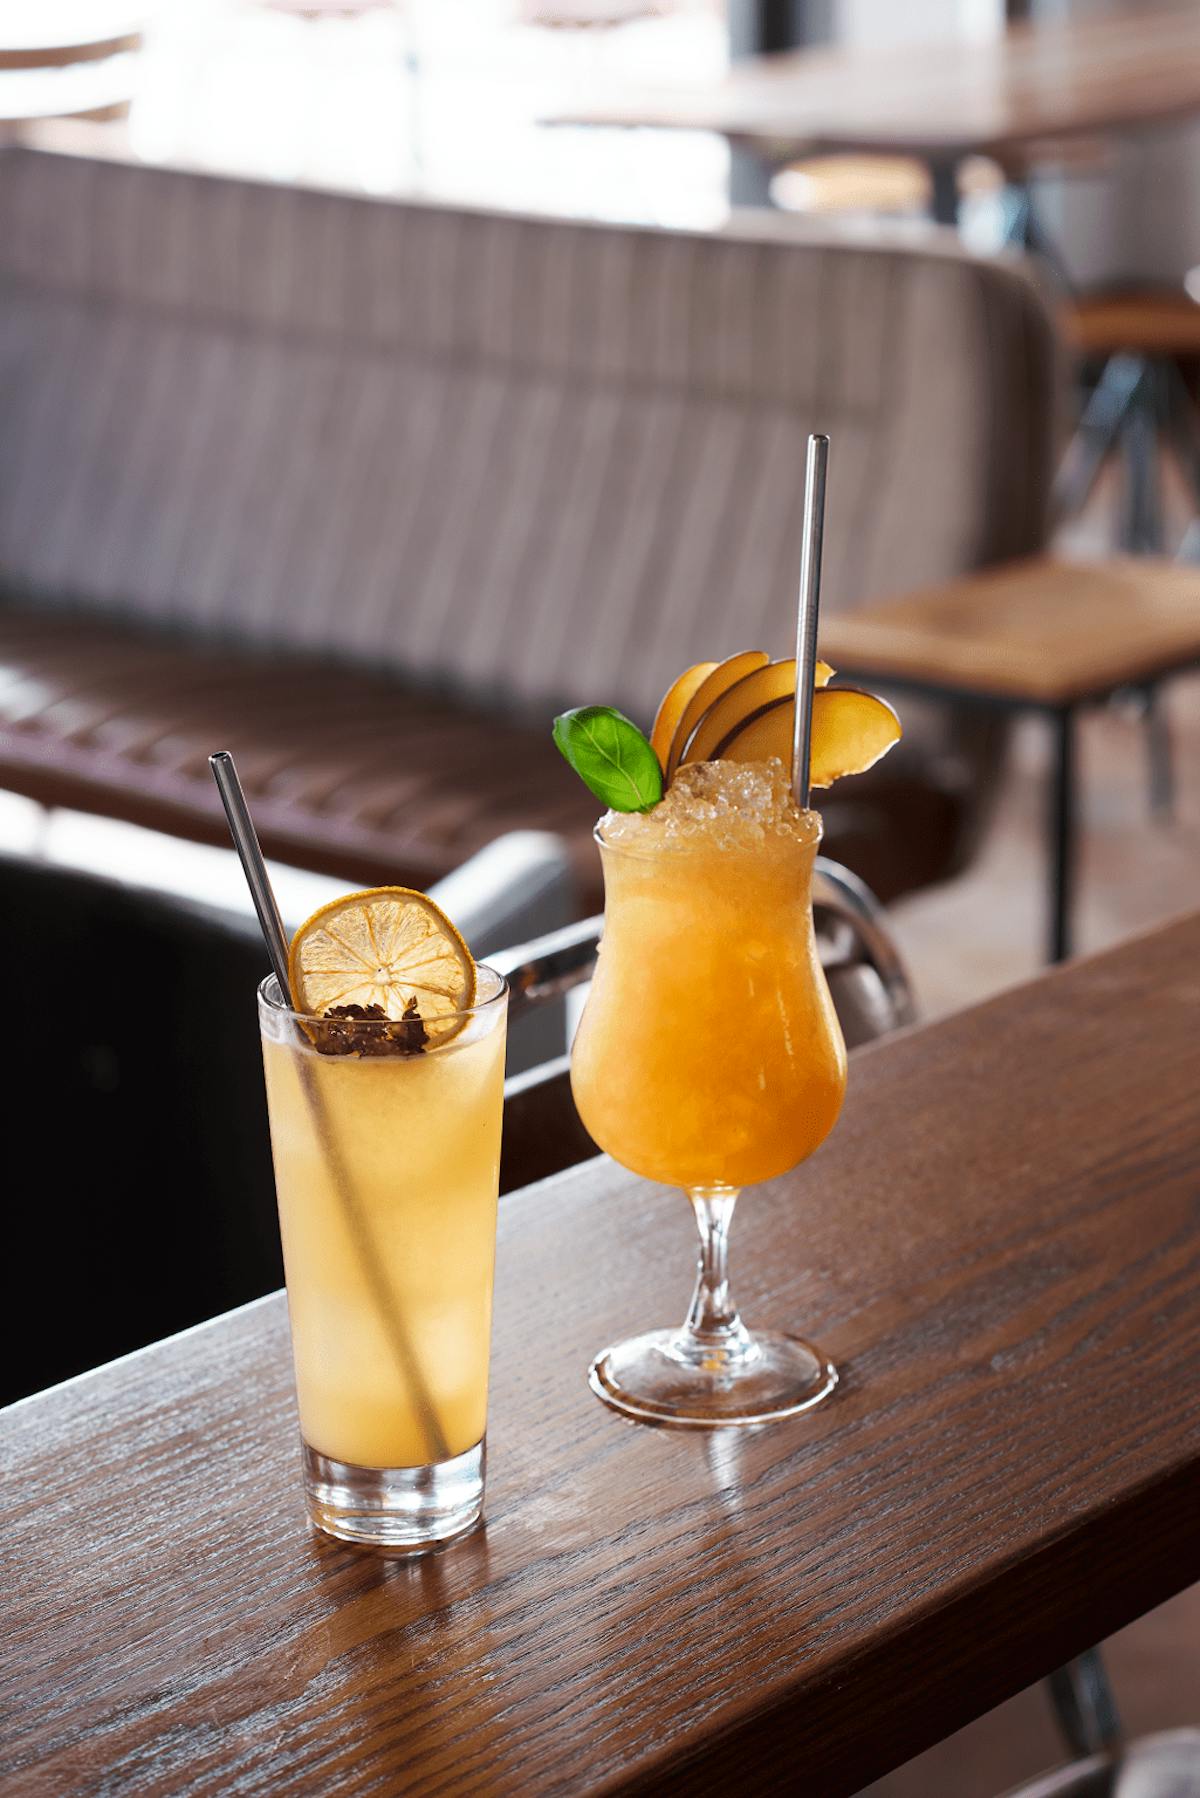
[209,750,450,1462]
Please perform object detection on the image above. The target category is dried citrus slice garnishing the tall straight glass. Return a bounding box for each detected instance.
[288,886,475,1043]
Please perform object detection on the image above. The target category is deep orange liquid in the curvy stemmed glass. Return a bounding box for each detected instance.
[570,813,846,1188]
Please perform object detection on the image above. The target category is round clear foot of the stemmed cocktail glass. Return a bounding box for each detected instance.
[588,1327,838,1429]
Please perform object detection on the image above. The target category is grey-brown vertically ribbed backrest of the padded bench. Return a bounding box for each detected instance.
[0,149,1054,716]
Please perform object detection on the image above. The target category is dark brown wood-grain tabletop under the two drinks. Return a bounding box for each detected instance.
[0,915,1200,1798]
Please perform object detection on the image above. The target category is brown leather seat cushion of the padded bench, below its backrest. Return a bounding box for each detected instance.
[0,606,973,913]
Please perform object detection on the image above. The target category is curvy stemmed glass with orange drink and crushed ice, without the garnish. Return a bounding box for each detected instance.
[572,762,846,1428]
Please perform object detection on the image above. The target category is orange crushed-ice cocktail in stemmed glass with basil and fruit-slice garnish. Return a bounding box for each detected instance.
[556,651,900,1426]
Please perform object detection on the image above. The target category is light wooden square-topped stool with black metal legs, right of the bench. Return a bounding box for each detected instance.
[820,556,1200,962]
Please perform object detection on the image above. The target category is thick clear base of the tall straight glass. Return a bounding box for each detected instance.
[304,1442,484,1552]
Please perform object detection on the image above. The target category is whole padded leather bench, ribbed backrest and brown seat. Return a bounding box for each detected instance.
[0,149,1056,910]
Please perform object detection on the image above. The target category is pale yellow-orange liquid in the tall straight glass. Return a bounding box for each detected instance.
[263,1010,504,1467]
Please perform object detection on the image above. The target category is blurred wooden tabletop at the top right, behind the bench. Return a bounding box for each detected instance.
[552,4,1200,223]
